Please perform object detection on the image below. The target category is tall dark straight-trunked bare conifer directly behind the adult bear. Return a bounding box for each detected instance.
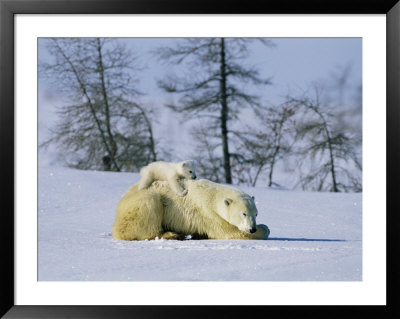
[155,38,272,184]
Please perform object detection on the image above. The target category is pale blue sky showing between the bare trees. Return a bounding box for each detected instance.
[38,38,362,166]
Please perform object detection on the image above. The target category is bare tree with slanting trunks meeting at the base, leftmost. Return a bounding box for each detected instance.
[40,38,157,171]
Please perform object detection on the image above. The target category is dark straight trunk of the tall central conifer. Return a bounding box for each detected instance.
[220,38,232,184]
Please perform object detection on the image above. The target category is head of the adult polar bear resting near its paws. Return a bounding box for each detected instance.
[218,194,258,234]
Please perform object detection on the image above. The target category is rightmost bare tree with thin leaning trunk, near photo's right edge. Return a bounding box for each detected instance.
[290,87,361,192]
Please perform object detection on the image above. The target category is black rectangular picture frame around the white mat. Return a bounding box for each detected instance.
[0,0,400,318]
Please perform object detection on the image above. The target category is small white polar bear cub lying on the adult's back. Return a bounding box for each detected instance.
[139,161,197,196]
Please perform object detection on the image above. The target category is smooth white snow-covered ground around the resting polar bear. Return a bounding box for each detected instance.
[38,167,362,281]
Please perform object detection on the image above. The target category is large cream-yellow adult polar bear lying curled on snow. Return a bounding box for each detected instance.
[112,180,269,240]
